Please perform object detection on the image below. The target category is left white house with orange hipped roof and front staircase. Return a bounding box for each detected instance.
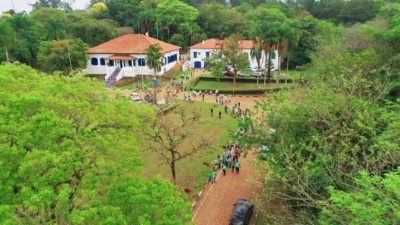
[87,34,181,87]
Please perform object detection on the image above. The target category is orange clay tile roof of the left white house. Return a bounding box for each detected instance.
[88,34,181,54]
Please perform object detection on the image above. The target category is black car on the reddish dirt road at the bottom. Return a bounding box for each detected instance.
[229,199,254,225]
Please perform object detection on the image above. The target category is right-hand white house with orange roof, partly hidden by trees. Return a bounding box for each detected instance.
[190,38,279,69]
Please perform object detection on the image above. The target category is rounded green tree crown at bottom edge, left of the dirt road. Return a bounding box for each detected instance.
[108,177,192,225]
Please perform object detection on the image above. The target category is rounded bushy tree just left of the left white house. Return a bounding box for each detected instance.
[38,39,89,75]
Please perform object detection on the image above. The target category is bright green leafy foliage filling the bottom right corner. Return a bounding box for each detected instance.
[319,168,400,225]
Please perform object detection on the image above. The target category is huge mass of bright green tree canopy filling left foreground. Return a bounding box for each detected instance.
[0,63,191,225]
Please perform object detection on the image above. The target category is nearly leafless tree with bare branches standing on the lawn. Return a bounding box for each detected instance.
[144,104,214,184]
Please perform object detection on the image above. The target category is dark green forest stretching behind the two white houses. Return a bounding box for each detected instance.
[0,0,397,74]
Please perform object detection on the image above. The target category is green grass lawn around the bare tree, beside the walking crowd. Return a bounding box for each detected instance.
[141,102,237,200]
